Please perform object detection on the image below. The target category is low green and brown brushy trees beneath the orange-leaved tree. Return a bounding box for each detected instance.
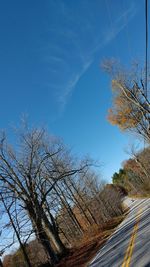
[112,147,150,195]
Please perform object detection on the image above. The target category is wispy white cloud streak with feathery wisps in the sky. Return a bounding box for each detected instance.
[41,1,137,115]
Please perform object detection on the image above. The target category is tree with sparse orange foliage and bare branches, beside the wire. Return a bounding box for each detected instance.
[102,60,150,143]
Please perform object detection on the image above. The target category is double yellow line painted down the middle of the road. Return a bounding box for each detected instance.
[122,209,142,267]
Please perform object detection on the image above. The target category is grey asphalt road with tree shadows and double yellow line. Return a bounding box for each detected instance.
[89,198,150,267]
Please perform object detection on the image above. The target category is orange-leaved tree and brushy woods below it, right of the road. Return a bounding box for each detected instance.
[102,59,150,196]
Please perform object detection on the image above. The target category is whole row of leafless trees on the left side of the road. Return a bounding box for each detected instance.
[0,128,122,267]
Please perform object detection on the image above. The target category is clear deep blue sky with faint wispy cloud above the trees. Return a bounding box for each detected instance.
[0,0,145,181]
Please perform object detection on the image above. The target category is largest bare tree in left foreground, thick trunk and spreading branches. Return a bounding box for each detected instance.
[0,129,91,263]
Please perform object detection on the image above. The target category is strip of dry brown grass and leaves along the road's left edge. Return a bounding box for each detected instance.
[56,215,124,267]
